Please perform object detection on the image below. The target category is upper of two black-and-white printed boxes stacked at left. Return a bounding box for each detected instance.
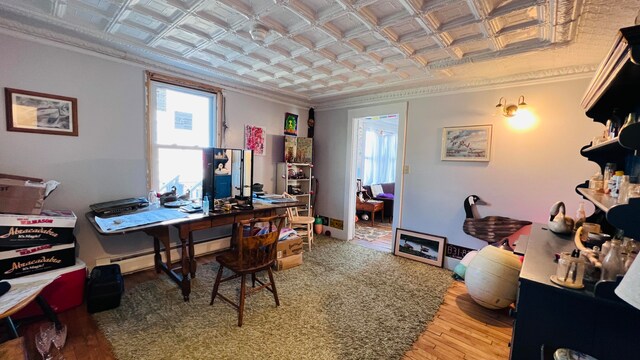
[0,210,77,251]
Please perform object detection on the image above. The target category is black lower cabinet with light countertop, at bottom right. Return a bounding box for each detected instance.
[510,224,640,360]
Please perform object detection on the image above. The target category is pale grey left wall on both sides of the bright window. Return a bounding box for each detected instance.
[0,34,308,266]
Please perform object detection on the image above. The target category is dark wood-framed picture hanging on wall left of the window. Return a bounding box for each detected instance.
[4,88,78,136]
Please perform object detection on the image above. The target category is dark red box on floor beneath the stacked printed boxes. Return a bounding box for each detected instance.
[11,259,87,319]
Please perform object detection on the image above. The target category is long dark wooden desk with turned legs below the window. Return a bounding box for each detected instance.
[85,202,302,301]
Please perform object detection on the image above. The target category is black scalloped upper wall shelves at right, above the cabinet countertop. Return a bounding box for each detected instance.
[576,26,640,239]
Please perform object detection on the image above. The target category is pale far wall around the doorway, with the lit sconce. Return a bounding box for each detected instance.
[315,79,603,267]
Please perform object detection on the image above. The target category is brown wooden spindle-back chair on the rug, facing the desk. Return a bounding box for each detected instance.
[209,215,285,326]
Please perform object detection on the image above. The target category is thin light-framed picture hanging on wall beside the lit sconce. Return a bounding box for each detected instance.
[441,125,492,161]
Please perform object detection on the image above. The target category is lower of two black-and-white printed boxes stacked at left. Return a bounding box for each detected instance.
[0,242,76,280]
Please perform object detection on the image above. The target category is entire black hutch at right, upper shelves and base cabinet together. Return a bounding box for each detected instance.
[510,26,640,360]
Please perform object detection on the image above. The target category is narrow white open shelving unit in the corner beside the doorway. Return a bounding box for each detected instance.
[276,163,313,215]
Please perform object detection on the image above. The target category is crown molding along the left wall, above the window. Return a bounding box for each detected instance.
[0,8,310,107]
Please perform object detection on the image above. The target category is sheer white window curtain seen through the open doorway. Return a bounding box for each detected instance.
[362,129,398,185]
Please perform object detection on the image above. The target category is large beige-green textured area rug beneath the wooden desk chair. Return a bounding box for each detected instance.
[94,236,452,360]
